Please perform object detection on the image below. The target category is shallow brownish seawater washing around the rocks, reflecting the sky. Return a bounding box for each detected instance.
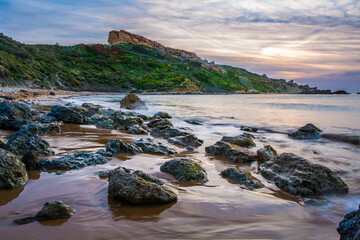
[0,96,360,239]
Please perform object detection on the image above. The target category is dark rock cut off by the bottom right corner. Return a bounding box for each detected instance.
[336,206,360,240]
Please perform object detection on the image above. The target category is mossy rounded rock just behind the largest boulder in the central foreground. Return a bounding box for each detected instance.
[160,158,208,183]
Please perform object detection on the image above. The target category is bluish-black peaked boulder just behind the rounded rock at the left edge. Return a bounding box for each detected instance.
[5,124,53,155]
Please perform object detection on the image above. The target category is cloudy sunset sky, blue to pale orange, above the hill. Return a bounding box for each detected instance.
[0,0,360,92]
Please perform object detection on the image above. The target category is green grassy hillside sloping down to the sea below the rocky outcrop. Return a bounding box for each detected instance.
[0,31,324,93]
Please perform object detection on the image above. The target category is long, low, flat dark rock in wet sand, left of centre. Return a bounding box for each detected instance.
[39,152,111,171]
